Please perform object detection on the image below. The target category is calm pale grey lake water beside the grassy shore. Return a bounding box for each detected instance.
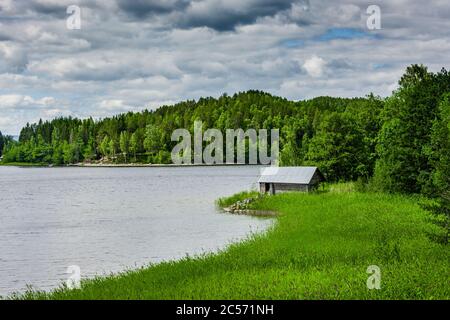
[0,167,272,295]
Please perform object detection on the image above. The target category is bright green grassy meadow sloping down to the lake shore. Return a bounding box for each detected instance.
[14,187,450,299]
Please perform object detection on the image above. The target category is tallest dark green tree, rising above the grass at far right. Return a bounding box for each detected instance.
[375,65,450,193]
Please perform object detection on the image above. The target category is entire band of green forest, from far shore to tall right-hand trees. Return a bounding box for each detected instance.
[0,65,450,199]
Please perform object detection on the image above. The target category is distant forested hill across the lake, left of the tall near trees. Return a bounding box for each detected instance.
[1,91,383,179]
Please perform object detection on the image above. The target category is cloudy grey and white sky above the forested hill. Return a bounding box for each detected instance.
[0,0,450,134]
